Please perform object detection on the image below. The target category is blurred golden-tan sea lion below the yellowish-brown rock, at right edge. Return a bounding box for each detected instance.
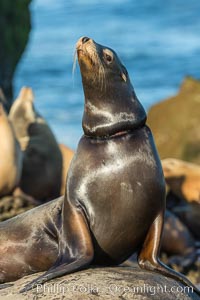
[162,158,200,204]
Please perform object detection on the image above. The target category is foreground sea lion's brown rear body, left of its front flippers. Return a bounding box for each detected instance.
[0,197,63,283]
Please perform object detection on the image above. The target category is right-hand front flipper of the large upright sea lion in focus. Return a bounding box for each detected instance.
[138,211,200,295]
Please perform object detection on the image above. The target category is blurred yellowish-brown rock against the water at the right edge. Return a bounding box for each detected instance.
[148,77,200,164]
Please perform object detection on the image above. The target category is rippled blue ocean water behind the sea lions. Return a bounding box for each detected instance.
[14,0,200,149]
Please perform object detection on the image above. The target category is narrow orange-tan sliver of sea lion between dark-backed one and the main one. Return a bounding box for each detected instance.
[59,144,74,195]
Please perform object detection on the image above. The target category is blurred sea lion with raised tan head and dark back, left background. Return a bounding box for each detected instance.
[9,87,62,202]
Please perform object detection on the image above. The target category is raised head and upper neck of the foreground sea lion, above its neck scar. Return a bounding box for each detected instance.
[76,37,146,137]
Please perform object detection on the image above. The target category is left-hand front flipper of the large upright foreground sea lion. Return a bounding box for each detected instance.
[20,201,94,293]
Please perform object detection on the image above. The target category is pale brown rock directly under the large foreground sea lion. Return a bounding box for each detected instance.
[0,267,200,300]
